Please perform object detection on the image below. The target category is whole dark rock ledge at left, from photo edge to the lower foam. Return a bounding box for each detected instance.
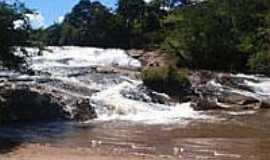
[0,82,97,123]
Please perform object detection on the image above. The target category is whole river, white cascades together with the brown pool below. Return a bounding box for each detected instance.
[0,47,270,160]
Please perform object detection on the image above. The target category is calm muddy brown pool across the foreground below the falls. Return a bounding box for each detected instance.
[0,110,270,160]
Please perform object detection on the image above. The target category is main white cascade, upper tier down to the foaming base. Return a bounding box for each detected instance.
[24,47,202,123]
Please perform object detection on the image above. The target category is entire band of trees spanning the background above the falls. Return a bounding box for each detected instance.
[0,0,270,74]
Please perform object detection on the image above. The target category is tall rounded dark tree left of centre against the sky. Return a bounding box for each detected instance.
[54,0,112,47]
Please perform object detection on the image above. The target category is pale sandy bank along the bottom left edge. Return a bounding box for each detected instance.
[0,144,158,160]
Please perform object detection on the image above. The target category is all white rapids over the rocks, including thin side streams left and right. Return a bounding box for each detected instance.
[4,46,270,124]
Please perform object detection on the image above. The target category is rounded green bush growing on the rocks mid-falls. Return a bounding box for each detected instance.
[142,67,190,95]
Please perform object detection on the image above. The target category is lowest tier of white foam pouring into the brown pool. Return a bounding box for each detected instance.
[91,81,202,124]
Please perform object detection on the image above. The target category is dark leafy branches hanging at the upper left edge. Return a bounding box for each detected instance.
[0,1,30,69]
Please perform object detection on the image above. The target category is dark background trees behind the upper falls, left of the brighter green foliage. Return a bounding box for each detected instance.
[43,0,166,48]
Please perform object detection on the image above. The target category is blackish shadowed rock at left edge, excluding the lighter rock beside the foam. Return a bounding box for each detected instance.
[0,83,69,122]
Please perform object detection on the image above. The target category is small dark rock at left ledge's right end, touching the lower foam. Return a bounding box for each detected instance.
[73,99,97,121]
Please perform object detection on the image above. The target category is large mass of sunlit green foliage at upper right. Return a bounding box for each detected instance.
[163,0,270,71]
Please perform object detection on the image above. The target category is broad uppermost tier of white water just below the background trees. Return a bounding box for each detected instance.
[32,47,141,69]
